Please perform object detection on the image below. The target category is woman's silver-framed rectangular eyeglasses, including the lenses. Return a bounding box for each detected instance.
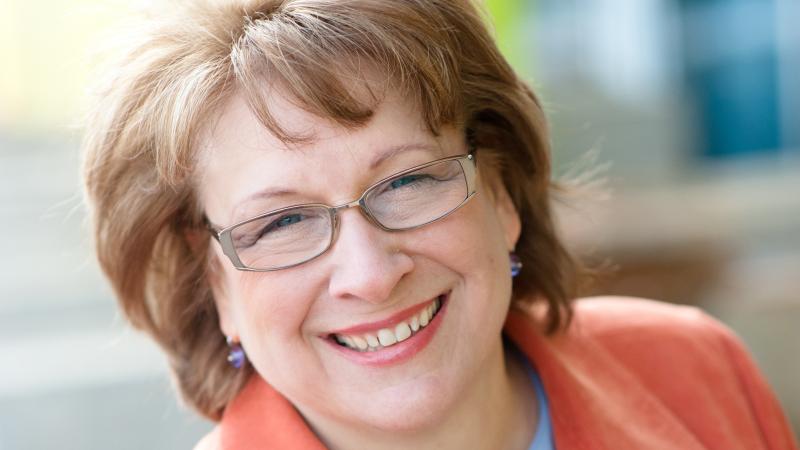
[209,154,476,272]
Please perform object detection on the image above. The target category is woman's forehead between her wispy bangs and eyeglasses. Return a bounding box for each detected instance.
[196,87,464,224]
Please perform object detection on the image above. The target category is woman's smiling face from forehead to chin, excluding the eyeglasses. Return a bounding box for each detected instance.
[198,87,520,431]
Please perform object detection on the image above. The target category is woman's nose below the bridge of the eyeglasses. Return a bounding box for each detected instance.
[328,208,414,303]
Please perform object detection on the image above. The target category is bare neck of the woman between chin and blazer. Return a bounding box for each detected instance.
[310,339,538,450]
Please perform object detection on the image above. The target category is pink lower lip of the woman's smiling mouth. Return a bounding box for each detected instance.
[326,294,450,367]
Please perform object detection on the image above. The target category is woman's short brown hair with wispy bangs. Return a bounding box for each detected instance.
[84,0,577,420]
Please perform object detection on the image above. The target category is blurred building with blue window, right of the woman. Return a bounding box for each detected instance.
[517,0,800,429]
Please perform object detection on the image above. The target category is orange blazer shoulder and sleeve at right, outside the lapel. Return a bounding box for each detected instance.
[567,297,798,450]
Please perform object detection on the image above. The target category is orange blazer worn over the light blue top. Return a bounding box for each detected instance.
[209,298,798,450]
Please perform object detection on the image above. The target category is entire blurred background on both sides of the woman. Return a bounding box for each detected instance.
[0,0,800,450]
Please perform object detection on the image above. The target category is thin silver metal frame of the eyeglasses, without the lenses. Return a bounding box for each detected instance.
[206,153,477,272]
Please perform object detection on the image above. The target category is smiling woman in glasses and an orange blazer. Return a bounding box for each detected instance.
[85,0,796,449]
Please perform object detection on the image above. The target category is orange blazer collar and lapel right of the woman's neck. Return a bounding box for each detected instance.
[504,310,704,450]
